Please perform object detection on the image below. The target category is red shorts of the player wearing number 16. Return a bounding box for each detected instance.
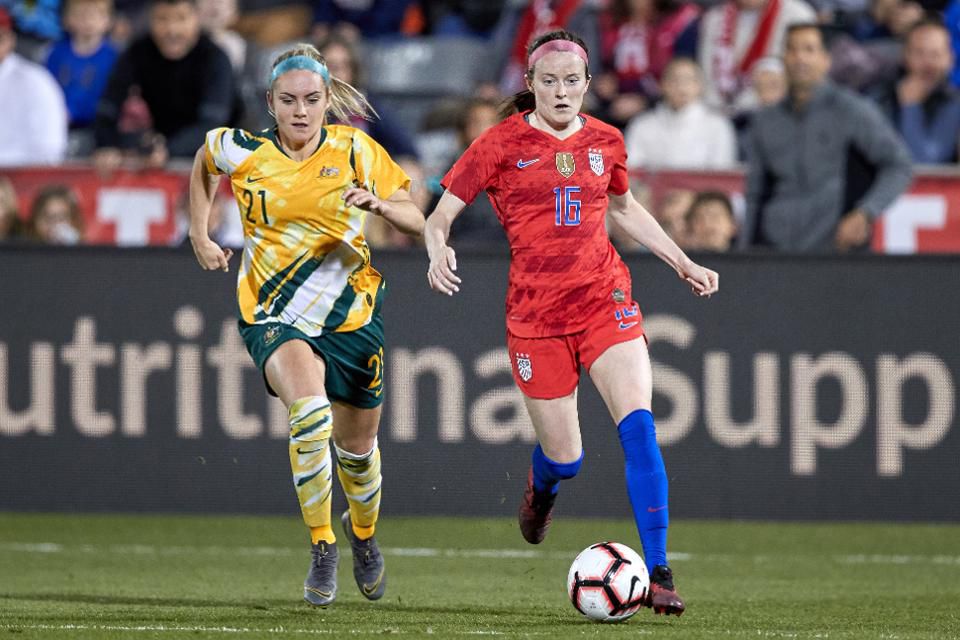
[507,297,643,400]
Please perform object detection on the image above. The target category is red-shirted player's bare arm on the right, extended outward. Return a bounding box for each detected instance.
[609,191,720,296]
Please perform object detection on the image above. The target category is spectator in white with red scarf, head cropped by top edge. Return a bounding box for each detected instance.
[697,0,815,109]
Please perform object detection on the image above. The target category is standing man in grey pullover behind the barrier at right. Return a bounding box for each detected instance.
[742,23,911,251]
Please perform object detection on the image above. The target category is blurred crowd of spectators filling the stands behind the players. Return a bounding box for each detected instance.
[0,0,960,252]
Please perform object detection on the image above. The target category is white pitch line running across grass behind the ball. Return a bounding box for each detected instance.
[0,542,960,567]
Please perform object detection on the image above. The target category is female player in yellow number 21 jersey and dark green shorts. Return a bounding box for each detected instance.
[190,45,424,606]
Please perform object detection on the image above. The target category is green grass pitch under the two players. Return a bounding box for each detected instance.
[0,513,960,640]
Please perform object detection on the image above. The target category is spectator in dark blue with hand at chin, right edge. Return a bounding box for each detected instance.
[874,19,960,164]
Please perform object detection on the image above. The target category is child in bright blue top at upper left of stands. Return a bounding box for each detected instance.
[47,0,117,153]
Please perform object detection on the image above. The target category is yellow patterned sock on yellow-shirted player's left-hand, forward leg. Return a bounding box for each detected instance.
[289,396,336,542]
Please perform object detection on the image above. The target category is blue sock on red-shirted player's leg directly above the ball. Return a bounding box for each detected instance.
[618,409,670,571]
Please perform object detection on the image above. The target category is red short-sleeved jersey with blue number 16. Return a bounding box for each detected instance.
[441,113,630,338]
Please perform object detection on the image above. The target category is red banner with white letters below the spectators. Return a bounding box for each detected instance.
[5,167,960,253]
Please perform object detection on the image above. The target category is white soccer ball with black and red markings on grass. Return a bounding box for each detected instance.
[567,542,650,622]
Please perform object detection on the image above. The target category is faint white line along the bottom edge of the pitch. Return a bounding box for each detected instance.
[5,624,548,637]
